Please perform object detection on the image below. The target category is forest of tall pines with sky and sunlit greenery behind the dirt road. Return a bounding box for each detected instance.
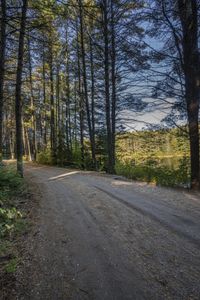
[0,0,200,188]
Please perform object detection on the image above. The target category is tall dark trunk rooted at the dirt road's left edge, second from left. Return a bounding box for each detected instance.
[15,0,28,177]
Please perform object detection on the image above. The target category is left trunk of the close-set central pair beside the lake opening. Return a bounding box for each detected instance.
[103,0,114,173]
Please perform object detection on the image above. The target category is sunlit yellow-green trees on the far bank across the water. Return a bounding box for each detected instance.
[116,128,189,164]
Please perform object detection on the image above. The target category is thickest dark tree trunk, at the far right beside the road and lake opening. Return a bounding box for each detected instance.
[178,0,200,188]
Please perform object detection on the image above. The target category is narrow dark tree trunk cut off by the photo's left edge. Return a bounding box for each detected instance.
[0,0,6,163]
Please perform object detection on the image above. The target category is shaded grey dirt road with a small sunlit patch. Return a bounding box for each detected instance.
[18,165,200,300]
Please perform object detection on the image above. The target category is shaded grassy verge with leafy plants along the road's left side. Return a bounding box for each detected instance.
[0,165,29,297]
